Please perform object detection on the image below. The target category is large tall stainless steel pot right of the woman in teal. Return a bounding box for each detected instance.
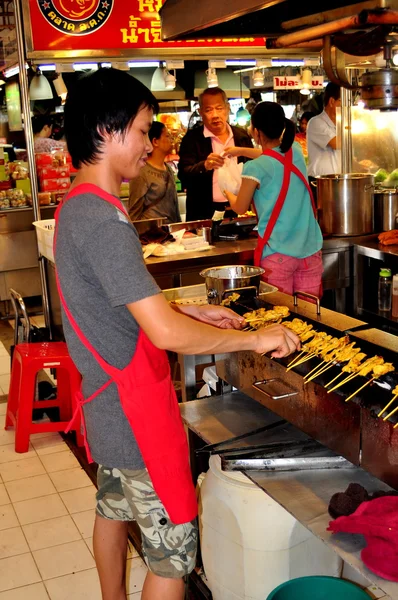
[316,173,374,236]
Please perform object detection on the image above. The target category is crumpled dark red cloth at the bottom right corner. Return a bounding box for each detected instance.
[328,496,398,581]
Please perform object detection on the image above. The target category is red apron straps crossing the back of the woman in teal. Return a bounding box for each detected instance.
[254,148,316,267]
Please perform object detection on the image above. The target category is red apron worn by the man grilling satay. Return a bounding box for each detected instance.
[54,184,197,524]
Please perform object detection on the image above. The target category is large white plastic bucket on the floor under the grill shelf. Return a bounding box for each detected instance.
[199,456,342,600]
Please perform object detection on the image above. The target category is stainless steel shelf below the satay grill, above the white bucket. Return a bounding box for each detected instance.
[180,392,398,600]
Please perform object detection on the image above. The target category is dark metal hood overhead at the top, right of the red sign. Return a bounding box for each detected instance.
[160,0,360,40]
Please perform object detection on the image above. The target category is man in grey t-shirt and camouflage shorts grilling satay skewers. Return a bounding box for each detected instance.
[55,69,299,600]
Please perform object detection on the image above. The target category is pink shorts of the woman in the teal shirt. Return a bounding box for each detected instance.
[261,251,323,297]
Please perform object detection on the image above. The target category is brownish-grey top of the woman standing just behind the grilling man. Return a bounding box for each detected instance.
[129,163,181,223]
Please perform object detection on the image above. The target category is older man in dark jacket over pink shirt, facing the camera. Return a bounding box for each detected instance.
[178,88,253,221]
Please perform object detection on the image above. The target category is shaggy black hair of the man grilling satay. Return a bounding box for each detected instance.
[65,68,159,169]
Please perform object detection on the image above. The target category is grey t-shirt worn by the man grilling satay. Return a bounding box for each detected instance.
[56,193,160,469]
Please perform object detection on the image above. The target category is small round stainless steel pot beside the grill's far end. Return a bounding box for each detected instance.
[200,265,264,304]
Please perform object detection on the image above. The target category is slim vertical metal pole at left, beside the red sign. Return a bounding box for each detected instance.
[14,0,50,336]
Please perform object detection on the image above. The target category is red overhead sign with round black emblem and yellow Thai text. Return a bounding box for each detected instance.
[29,0,264,51]
